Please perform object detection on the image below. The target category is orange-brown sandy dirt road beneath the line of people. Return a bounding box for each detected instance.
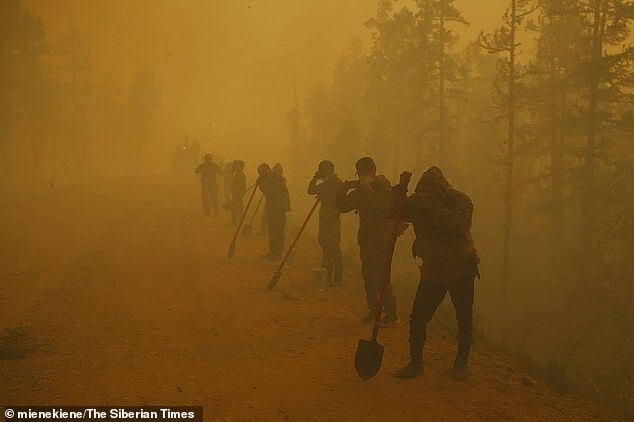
[0,180,617,421]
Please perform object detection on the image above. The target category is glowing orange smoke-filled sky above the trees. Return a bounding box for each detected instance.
[26,0,506,154]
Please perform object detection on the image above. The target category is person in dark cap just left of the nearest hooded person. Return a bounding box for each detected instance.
[337,157,399,326]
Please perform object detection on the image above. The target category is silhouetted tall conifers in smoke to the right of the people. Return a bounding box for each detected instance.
[289,0,634,410]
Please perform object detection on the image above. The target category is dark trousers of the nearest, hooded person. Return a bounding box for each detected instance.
[409,274,475,361]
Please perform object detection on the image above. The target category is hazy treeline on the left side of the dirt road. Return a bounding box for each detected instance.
[0,0,168,188]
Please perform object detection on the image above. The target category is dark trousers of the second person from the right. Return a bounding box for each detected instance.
[360,245,396,316]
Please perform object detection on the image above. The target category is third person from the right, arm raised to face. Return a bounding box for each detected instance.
[308,160,343,286]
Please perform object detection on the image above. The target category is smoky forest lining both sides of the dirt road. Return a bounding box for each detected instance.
[0,0,634,412]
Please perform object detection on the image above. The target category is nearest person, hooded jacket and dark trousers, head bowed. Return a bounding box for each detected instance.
[396,167,480,380]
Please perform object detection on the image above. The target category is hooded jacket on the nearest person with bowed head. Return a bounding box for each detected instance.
[402,167,479,284]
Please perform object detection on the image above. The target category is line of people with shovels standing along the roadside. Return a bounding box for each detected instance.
[196,154,479,379]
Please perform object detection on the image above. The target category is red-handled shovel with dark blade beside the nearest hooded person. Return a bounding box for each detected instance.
[354,172,412,380]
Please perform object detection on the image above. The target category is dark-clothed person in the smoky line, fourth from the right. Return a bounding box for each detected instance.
[256,163,291,261]
